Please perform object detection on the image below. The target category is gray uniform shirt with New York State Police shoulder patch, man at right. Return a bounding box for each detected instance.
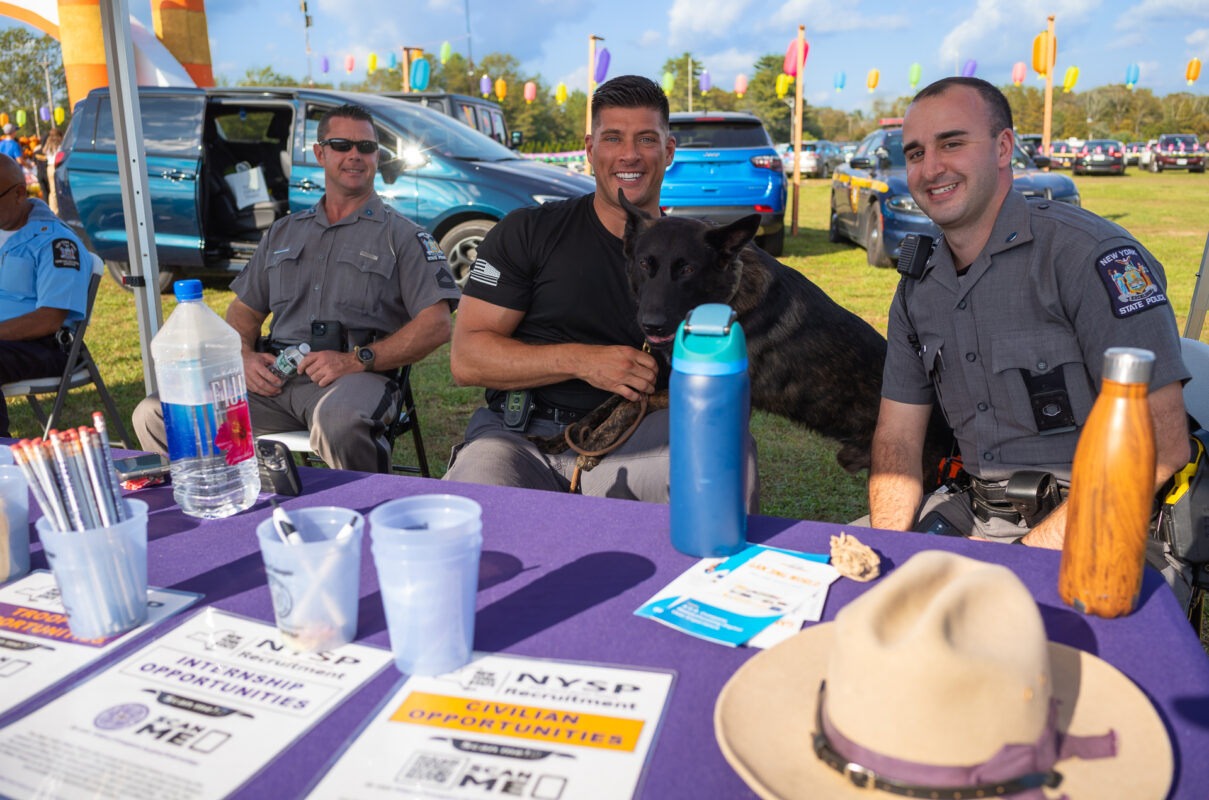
[881,191,1188,481]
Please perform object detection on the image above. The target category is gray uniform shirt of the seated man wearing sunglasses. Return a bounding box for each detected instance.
[231,195,461,342]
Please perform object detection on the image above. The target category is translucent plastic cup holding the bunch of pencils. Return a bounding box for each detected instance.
[36,498,147,639]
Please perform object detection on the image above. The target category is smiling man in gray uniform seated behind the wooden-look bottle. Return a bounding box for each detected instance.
[869,77,1188,547]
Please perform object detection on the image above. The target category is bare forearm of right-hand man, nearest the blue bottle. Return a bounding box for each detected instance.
[869,398,932,531]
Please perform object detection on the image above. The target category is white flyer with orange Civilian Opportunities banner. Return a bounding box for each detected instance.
[308,655,675,800]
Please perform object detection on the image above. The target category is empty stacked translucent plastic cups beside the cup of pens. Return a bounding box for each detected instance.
[370,494,482,676]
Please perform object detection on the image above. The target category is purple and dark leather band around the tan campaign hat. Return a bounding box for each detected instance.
[812,682,1117,800]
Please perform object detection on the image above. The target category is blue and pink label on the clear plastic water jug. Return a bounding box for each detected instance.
[161,372,255,465]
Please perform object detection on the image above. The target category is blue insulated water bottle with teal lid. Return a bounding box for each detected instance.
[669,303,751,558]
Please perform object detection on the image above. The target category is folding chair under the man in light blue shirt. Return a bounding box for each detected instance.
[0,253,133,447]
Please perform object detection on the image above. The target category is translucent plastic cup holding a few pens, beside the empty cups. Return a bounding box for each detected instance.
[256,506,365,653]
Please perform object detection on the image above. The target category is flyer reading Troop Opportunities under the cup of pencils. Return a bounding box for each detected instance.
[0,569,201,718]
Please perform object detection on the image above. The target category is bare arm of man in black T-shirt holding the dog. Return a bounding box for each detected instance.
[450,297,659,400]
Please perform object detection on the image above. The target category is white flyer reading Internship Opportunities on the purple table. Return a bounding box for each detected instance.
[0,608,392,800]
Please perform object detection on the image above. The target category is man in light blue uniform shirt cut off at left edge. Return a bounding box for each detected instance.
[0,155,92,436]
